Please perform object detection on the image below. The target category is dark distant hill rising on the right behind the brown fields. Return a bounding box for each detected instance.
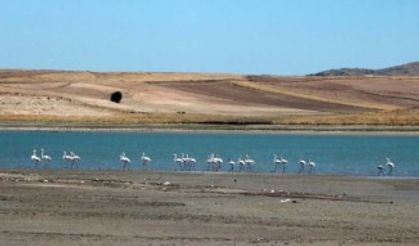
[308,62,419,76]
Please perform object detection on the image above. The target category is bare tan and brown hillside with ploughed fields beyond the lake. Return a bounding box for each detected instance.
[0,70,419,125]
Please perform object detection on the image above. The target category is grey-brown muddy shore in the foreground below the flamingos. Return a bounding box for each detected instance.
[0,170,419,246]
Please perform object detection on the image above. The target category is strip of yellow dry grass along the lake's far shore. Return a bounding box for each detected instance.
[0,109,419,127]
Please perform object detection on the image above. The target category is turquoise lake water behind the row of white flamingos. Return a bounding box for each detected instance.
[0,131,419,177]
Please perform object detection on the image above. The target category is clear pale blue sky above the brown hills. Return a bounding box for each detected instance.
[0,0,419,75]
